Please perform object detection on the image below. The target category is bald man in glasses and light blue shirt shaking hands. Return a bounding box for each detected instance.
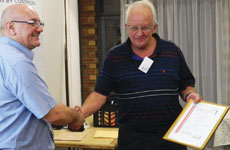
[0,4,84,150]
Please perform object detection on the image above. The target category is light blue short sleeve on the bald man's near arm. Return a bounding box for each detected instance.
[6,61,57,119]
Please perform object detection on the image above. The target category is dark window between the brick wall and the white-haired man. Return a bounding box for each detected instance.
[97,0,121,68]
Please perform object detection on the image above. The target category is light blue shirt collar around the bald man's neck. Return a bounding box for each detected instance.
[0,36,34,61]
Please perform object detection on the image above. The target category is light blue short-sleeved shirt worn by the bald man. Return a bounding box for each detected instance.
[0,36,57,150]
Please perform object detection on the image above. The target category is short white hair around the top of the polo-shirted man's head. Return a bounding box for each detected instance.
[125,0,158,25]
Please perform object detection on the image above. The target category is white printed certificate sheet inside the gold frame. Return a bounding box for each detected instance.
[168,102,226,147]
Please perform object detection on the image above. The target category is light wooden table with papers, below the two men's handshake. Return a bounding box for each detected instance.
[53,116,118,150]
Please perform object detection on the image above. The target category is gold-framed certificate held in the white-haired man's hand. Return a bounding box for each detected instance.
[163,100,229,149]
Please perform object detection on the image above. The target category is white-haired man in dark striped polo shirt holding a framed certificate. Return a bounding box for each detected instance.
[81,0,202,150]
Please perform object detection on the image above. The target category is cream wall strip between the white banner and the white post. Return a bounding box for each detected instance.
[41,0,66,104]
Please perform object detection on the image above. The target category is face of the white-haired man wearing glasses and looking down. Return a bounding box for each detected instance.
[126,6,156,50]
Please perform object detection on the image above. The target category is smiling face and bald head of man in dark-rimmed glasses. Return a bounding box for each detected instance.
[2,4,43,50]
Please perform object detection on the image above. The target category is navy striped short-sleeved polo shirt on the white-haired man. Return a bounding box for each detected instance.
[95,34,195,132]
